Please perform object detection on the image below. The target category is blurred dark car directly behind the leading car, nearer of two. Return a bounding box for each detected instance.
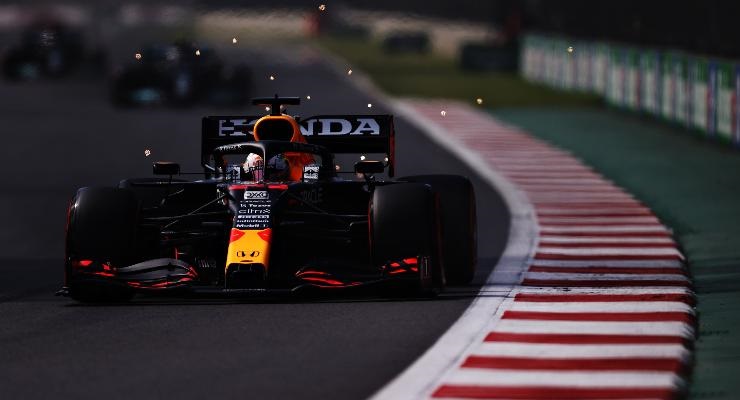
[111,42,252,107]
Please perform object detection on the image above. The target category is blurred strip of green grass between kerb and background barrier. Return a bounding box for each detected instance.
[318,37,600,108]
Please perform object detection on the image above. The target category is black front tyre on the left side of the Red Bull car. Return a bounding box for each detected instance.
[65,187,139,303]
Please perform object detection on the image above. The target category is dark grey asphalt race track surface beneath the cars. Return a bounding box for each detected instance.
[0,41,509,399]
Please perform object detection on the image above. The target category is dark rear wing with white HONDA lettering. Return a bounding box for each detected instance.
[201,115,396,176]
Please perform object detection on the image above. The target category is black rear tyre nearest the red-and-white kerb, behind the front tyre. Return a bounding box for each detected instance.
[399,175,478,285]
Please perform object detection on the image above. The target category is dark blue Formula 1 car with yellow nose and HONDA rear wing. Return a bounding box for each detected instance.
[60,96,477,302]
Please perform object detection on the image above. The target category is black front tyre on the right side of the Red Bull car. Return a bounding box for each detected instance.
[369,183,445,296]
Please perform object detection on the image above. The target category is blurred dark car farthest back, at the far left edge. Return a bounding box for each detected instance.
[2,21,105,81]
